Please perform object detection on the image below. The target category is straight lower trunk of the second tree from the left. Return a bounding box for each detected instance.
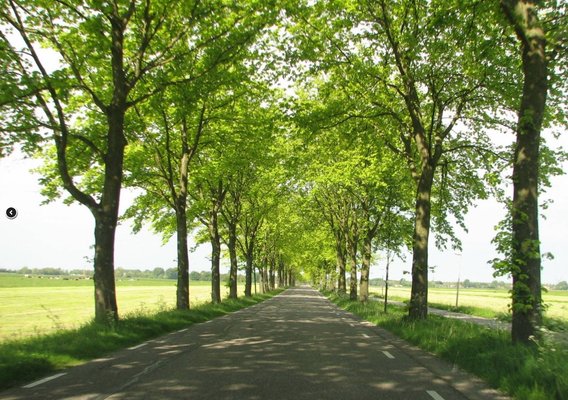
[176,197,189,310]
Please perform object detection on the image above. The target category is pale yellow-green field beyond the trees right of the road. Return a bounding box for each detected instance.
[370,287,568,321]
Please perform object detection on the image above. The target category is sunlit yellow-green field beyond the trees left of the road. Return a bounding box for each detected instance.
[0,273,258,341]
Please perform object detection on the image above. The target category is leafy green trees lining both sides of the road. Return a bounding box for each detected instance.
[0,0,568,342]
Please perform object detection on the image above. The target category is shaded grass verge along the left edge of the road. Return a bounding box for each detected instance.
[0,290,282,390]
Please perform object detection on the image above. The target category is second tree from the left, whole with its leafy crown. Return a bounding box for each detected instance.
[125,92,208,310]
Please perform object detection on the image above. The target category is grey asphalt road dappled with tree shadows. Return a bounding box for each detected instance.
[0,288,505,400]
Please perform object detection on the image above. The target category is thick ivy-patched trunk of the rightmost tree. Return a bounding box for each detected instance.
[501,0,548,343]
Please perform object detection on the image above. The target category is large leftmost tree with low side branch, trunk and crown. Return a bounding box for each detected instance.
[0,0,191,322]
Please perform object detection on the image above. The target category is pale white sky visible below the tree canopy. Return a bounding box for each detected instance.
[0,133,568,283]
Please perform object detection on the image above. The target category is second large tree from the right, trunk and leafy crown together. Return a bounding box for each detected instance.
[360,1,506,318]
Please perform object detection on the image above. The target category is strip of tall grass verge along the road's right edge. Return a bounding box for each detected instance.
[326,293,568,400]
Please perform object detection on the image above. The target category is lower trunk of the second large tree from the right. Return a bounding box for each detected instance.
[408,163,435,319]
